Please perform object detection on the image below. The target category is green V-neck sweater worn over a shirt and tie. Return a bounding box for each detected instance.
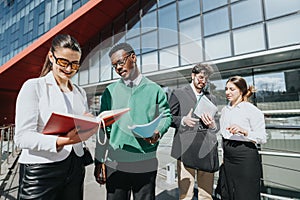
[95,77,172,162]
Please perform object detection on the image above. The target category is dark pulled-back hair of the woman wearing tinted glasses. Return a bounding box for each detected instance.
[40,34,81,77]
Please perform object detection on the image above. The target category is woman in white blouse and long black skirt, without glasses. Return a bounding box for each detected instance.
[220,76,266,200]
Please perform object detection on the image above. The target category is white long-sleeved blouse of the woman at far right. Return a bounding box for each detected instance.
[220,102,267,144]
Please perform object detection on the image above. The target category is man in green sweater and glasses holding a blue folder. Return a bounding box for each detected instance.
[94,43,172,200]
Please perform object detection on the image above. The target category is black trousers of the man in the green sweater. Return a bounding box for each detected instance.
[106,160,157,200]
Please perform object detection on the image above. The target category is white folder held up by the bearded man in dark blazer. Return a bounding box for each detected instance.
[194,95,218,117]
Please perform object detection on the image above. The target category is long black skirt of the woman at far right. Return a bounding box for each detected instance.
[223,139,262,200]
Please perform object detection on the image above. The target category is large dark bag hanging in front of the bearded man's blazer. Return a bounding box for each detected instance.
[180,130,219,173]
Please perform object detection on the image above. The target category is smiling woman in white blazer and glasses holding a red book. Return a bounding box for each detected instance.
[14,35,96,200]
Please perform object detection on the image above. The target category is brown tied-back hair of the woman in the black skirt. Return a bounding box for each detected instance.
[226,76,255,101]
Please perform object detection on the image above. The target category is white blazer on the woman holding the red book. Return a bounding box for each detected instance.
[14,71,88,164]
